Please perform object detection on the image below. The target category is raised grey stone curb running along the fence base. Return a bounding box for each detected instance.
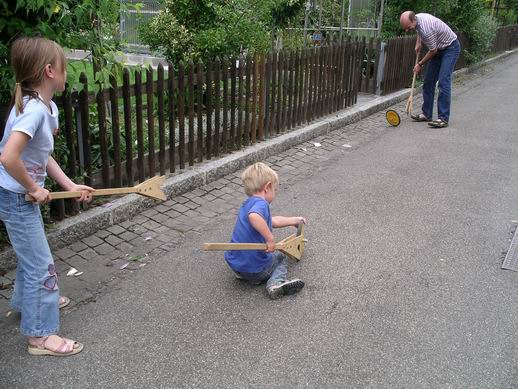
[0,49,518,270]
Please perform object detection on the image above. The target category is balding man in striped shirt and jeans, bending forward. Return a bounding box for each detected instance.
[399,11,460,128]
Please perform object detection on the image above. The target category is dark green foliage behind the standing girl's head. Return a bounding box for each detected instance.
[0,0,125,102]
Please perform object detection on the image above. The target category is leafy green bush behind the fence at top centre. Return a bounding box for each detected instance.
[139,0,305,63]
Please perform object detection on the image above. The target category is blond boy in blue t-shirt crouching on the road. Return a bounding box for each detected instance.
[225,162,306,299]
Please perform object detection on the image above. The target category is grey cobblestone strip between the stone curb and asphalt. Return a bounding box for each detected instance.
[0,96,420,332]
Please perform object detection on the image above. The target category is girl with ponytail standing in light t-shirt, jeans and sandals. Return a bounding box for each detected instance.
[0,37,93,356]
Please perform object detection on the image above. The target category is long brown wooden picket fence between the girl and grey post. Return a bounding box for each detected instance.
[47,40,380,219]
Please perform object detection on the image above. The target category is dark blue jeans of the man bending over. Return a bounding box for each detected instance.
[422,39,460,122]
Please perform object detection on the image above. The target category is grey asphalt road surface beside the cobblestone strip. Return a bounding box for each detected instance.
[0,56,518,388]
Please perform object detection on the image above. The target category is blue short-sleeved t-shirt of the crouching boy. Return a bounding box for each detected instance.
[225,196,273,273]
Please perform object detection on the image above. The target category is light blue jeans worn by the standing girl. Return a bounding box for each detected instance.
[0,187,59,336]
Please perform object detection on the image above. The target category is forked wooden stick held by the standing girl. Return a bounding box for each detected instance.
[25,176,167,201]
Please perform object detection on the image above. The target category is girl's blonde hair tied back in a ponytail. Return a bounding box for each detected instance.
[10,37,67,115]
